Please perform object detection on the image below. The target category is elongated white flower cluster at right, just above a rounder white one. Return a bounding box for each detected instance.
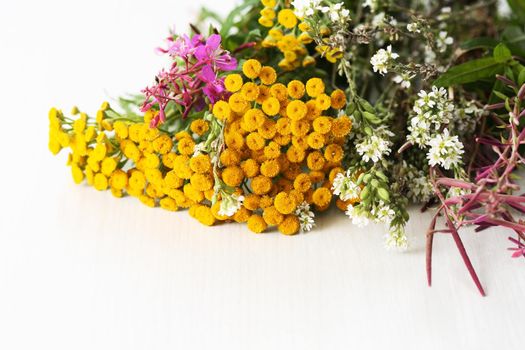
[408,86,455,148]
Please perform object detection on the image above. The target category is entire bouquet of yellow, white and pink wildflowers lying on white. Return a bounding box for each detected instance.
[49,0,525,294]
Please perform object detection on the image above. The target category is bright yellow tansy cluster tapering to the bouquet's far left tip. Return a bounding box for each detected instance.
[49,103,218,213]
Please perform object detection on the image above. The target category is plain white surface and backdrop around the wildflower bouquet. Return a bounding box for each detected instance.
[0,0,525,350]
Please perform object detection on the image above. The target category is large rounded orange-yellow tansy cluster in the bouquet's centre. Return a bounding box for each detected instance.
[213,59,352,234]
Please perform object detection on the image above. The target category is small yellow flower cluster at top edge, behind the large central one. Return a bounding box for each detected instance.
[259,0,315,70]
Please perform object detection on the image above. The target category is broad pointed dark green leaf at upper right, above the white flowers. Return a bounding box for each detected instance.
[434,57,503,87]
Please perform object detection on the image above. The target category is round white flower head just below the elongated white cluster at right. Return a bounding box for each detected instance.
[427,129,464,170]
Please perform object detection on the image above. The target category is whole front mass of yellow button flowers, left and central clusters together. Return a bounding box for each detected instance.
[49,59,352,235]
